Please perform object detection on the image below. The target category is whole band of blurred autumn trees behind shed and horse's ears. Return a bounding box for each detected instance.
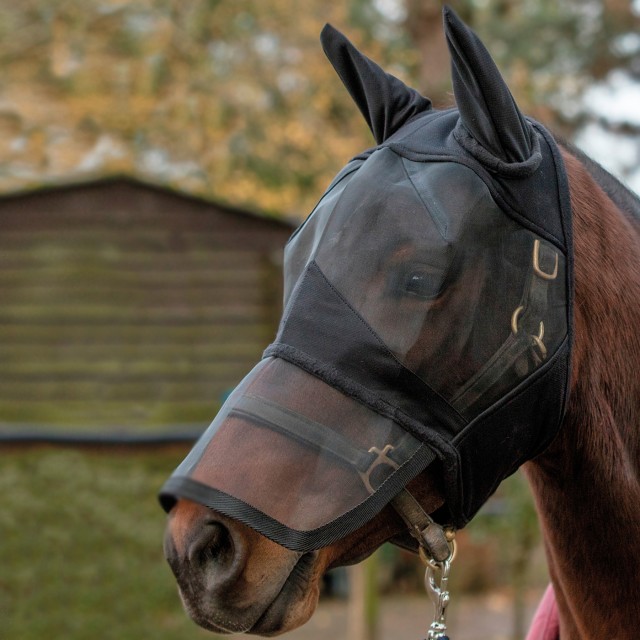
[0,0,640,215]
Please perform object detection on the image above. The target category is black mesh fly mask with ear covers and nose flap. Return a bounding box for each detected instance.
[161,10,572,551]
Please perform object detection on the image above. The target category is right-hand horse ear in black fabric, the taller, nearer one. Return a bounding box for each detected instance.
[444,7,537,165]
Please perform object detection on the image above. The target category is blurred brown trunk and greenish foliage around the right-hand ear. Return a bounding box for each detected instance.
[404,0,640,136]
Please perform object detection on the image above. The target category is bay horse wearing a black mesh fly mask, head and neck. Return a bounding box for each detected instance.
[161,9,640,640]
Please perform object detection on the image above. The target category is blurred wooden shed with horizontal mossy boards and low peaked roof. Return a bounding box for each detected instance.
[0,178,292,429]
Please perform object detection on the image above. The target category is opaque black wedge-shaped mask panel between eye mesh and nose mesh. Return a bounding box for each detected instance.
[263,262,468,440]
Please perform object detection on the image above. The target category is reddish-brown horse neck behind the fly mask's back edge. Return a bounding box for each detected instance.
[525,148,640,640]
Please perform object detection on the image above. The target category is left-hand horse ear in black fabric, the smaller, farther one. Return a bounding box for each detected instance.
[320,24,431,144]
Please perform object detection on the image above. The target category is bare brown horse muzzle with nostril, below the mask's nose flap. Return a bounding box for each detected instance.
[164,500,323,635]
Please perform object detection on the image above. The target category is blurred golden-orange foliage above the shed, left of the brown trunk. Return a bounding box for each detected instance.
[0,0,416,214]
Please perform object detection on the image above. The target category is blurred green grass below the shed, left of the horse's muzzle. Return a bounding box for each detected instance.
[0,449,220,640]
